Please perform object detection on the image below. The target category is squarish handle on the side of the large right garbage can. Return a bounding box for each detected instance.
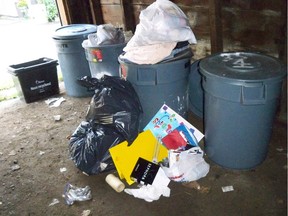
[241,82,267,105]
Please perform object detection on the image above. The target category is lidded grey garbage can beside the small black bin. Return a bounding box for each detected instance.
[53,24,97,97]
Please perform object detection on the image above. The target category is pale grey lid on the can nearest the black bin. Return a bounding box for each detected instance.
[53,24,97,40]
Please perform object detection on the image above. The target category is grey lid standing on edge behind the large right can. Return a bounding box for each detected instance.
[188,60,204,118]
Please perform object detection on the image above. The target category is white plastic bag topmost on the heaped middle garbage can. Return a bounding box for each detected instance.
[124,0,197,48]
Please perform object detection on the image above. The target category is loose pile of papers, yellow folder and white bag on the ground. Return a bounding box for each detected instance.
[109,104,210,202]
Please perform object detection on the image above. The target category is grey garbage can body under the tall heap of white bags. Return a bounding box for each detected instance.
[119,49,192,130]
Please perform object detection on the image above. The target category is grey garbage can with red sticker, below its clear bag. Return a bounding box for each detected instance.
[83,43,126,79]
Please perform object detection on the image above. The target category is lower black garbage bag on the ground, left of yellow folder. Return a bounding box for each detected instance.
[69,121,125,175]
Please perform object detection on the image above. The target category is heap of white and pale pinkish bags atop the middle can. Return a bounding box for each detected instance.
[120,0,197,64]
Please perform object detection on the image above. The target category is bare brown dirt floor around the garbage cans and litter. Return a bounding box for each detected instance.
[0,84,287,216]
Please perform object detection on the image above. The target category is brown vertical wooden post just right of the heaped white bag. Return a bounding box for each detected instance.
[209,0,223,53]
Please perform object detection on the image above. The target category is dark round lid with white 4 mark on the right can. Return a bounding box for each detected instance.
[199,52,287,82]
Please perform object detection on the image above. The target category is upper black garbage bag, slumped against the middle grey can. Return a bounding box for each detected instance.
[79,75,143,145]
